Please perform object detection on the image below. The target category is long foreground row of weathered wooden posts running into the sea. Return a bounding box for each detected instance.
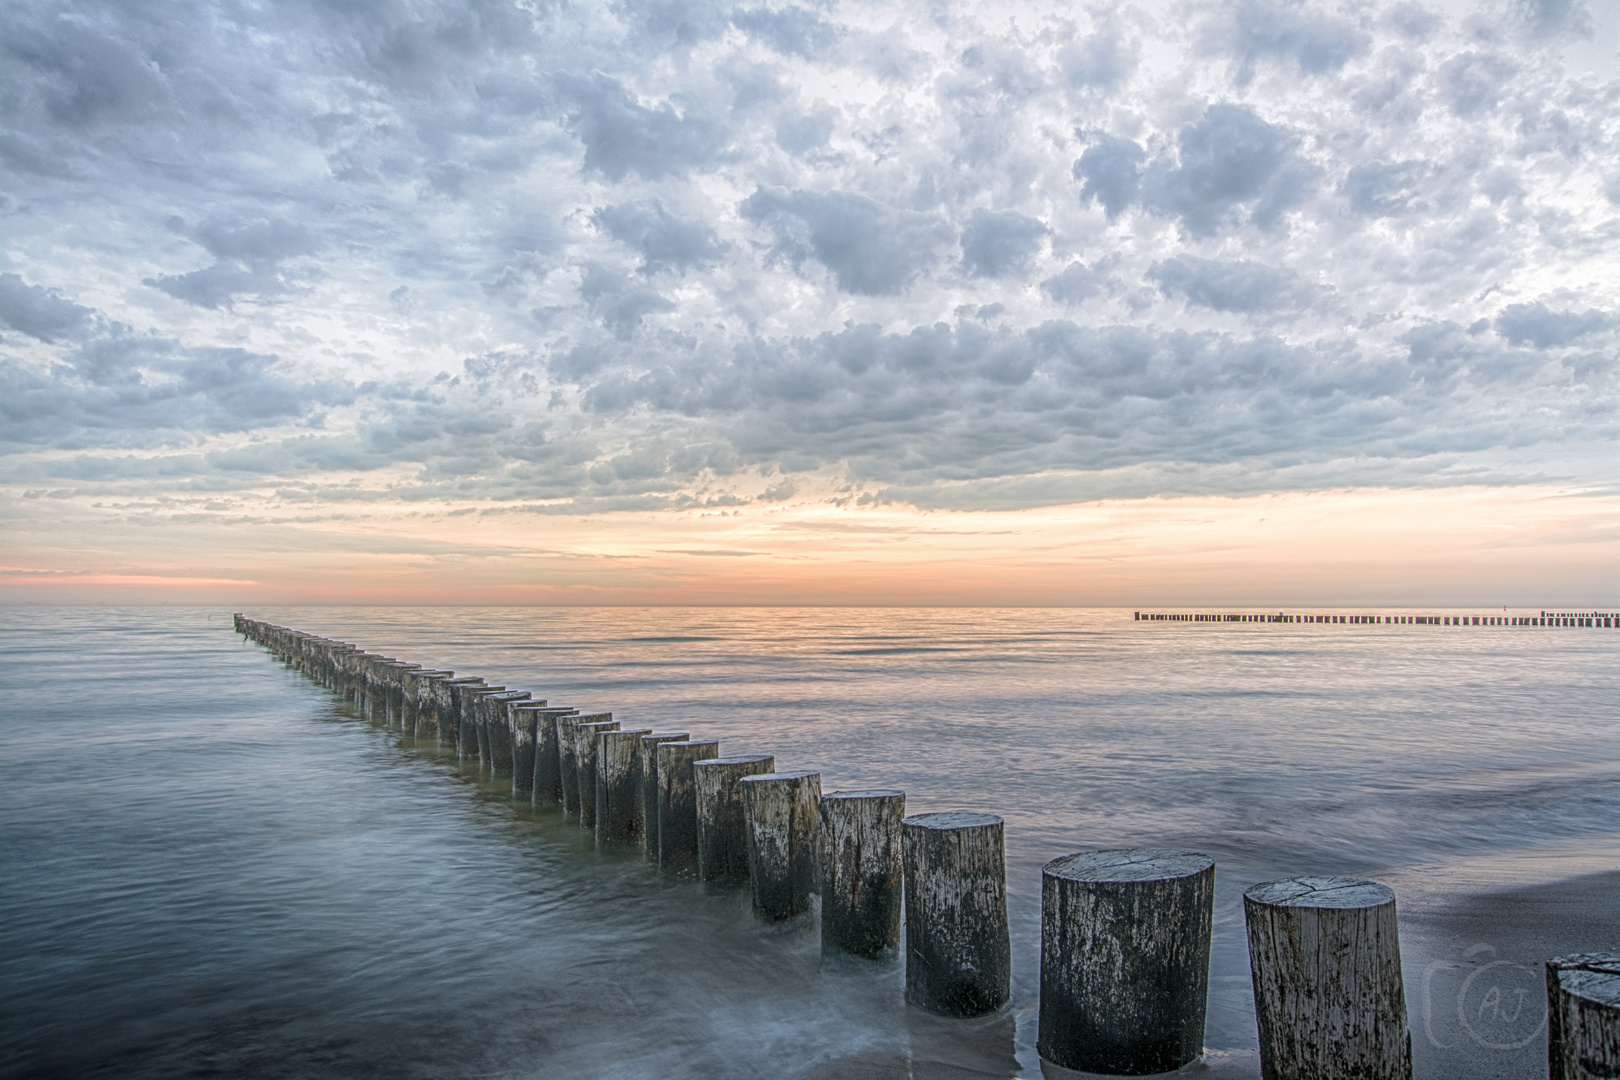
[235,614,1620,1080]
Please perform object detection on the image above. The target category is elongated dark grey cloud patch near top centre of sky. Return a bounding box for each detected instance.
[742,188,949,296]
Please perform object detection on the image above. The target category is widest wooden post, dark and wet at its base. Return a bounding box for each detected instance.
[1035,847,1215,1077]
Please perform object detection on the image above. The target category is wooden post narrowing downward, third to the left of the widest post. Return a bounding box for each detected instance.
[737,771,821,923]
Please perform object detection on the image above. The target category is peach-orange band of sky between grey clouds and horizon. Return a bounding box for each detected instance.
[0,487,1620,607]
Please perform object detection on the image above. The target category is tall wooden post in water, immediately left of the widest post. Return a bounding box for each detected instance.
[901,811,1013,1017]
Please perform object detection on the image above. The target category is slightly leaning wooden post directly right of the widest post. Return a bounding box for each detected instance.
[1243,878,1413,1080]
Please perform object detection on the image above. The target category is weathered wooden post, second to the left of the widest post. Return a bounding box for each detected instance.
[816,789,906,960]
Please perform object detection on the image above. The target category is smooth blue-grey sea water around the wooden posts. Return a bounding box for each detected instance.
[0,607,1620,1077]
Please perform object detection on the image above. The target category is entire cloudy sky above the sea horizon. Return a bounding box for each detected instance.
[0,0,1620,607]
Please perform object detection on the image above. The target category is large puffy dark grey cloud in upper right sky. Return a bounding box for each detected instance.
[1142,104,1315,235]
